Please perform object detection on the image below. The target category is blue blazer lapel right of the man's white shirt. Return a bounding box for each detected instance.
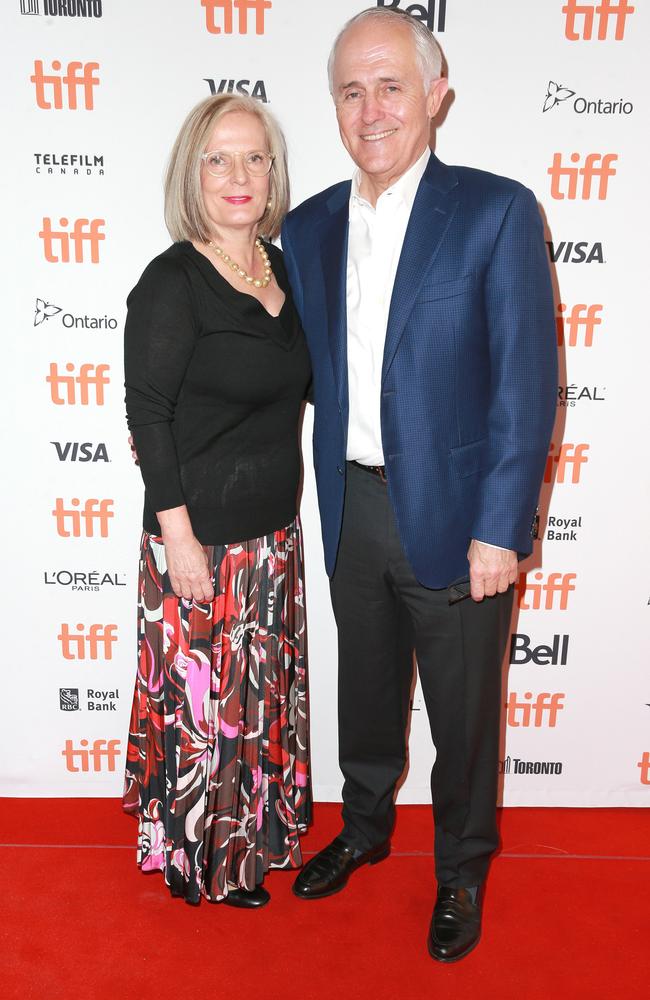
[381,154,458,381]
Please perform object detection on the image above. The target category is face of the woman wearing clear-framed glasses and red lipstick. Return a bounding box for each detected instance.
[201,111,270,236]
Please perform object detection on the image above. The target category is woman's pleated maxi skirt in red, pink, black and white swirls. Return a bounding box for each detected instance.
[123,518,311,903]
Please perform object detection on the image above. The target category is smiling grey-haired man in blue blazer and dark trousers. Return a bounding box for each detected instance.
[282,8,557,961]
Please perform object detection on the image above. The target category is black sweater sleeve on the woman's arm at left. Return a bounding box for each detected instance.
[124,257,198,511]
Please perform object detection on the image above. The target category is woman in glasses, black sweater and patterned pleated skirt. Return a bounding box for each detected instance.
[124,95,311,907]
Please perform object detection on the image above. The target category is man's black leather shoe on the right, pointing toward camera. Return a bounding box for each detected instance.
[427,885,481,962]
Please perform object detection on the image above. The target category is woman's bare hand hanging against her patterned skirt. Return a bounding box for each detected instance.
[158,507,214,603]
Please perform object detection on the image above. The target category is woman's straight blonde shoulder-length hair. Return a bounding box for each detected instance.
[165,94,289,243]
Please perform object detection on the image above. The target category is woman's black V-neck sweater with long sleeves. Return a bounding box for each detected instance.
[124,242,311,545]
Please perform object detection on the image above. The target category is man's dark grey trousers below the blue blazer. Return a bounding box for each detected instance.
[331,463,513,887]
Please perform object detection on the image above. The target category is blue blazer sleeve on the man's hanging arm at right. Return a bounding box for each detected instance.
[471,182,557,554]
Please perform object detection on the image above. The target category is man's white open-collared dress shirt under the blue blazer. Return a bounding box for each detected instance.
[346,149,431,465]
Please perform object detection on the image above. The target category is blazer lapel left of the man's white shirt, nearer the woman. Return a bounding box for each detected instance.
[319,183,350,410]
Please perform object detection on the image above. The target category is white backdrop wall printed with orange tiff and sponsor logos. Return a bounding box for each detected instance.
[0,0,650,806]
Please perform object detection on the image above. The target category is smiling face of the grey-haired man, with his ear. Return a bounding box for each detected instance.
[333,20,447,190]
